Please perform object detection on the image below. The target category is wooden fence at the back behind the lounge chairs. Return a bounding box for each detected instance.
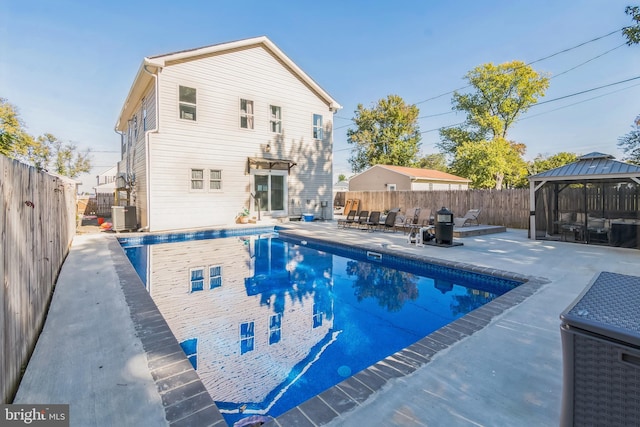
[345,188,529,229]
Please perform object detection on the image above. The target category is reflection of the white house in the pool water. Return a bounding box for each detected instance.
[147,236,337,413]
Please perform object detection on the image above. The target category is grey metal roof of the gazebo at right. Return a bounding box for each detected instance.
[529,152,640,181]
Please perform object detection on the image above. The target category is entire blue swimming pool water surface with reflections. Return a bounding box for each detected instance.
[121,233,520,425]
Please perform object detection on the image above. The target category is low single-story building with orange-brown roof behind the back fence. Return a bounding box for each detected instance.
[349,165,471,191]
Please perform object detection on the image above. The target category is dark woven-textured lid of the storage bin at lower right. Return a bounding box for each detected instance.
[560,271,640,348]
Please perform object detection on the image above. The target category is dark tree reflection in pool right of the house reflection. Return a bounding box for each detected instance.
[346,261,419,311]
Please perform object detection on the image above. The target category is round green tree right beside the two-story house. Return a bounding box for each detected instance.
[347,95,420,172]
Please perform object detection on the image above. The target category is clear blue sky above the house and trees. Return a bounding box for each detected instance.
[0,0,640,191]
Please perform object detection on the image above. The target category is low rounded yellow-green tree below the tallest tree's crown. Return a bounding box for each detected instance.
[451,138,527,190]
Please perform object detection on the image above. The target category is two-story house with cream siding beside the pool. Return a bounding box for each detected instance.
[116,37,341,231]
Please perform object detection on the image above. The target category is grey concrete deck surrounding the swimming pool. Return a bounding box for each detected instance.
[14,221,640,427]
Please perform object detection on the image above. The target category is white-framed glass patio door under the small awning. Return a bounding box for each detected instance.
[252,169,287,216]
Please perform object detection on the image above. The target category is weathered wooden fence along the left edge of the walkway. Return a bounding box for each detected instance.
[0,155,76,403]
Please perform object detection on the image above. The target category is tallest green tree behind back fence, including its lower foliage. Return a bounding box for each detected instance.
[438,61,549,189]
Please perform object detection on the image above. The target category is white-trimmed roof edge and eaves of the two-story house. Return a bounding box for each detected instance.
[116,36,342,131]
